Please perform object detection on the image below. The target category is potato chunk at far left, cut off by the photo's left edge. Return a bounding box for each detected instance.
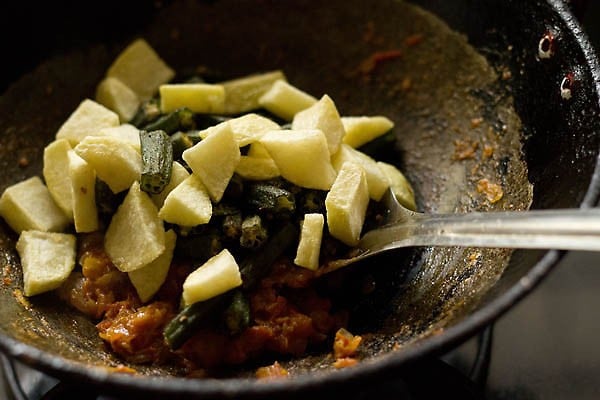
[0,176,71,233]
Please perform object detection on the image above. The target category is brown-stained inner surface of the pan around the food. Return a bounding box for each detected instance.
[0,0,533,376]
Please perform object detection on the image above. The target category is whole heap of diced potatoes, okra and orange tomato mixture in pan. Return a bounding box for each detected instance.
[0,39,415,377]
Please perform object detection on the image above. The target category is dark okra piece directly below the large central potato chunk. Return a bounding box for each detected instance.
[246,183,296,216]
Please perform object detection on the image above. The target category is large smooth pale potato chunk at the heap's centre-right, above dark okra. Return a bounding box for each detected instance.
[260,129,336,190]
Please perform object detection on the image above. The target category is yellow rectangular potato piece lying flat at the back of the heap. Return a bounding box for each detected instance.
[158,83,225,114]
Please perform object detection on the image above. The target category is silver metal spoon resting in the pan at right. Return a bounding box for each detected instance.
[320,190,600,273]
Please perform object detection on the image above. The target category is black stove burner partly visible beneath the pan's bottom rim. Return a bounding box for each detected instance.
[0,325,493,400]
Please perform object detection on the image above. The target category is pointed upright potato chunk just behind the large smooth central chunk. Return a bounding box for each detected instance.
[292,95,346,155]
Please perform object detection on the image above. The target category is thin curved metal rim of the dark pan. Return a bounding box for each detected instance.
[0,0,600,398]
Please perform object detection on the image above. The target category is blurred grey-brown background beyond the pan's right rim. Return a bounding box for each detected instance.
[478,0,600,400]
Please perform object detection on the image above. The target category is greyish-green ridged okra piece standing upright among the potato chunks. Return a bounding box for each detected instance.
[140,130,173,194]
